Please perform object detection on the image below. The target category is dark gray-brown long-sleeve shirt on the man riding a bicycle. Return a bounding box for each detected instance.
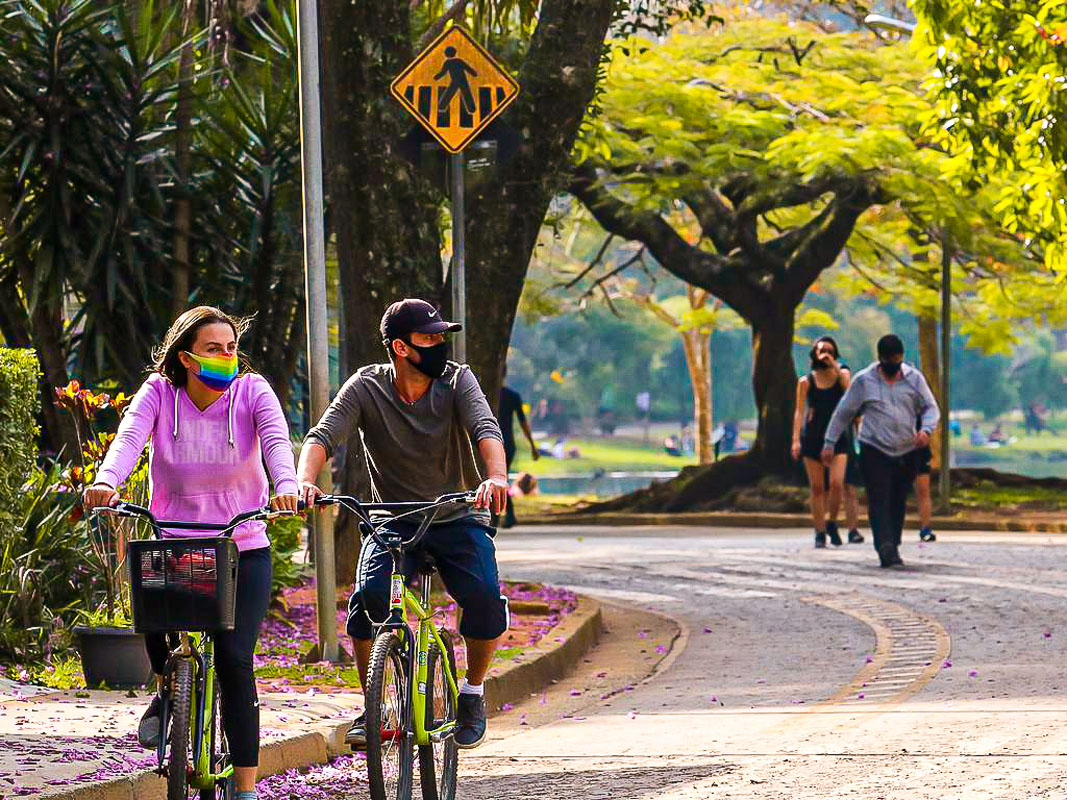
[304,362,504,521]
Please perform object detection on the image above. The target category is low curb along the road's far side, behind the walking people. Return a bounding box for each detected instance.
[522,511,1067,533]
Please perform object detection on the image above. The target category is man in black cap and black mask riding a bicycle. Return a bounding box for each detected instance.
[298,299,508,749]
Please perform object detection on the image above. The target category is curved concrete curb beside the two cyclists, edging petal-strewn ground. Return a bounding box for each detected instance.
[41,596,603,800]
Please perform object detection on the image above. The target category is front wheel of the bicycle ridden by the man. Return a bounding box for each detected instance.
[366,630,415,800]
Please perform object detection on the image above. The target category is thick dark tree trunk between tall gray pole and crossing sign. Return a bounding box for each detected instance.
[313,0,442,586]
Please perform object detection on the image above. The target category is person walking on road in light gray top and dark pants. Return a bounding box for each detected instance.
[823,334,940,567]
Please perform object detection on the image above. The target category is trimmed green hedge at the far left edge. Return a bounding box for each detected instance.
[0,348,41,511]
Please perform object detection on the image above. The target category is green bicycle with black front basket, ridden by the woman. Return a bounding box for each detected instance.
[93,502,291,800]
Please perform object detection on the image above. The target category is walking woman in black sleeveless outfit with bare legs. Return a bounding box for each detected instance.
[793,336,853,548]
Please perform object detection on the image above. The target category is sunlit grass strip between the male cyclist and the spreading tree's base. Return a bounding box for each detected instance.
[511,435,697,477]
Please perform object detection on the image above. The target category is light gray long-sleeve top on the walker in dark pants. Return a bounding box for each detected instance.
[824,362,941,455]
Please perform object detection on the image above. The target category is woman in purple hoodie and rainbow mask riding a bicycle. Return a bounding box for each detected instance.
[84,306,298,800]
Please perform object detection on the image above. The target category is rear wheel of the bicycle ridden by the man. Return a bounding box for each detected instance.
[418,630,459,800]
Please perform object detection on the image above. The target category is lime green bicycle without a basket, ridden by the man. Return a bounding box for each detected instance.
[316,493,475,800]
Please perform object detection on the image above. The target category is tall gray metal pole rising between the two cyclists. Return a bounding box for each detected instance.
[297,0,337,661]
